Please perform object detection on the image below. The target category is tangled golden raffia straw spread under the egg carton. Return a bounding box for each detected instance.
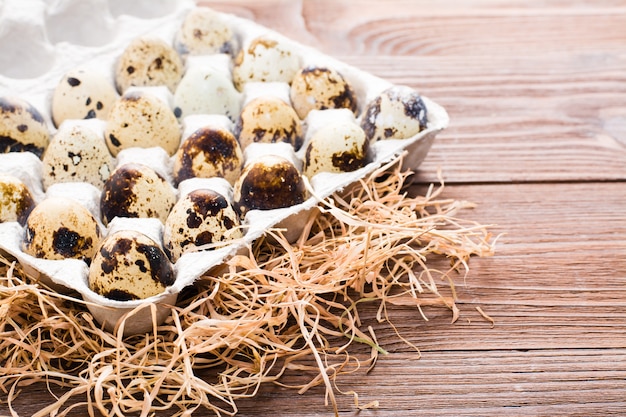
[0,157,494,417]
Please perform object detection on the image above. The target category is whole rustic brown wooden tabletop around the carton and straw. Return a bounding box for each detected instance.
[0,0,626,417]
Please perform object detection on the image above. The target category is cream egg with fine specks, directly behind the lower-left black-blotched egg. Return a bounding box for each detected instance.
[43,123,114,189]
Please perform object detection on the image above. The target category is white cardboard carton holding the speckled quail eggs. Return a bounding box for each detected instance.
[0,0,448,334]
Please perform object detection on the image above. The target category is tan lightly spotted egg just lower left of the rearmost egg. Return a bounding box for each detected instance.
[115,36,184,94]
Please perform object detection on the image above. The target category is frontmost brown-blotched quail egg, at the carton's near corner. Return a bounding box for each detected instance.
[89,230,176,301]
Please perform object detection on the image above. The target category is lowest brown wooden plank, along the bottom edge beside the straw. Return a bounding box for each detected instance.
[9,349,626,417]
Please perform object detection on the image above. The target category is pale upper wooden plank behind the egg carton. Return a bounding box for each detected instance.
[201,0,626,182]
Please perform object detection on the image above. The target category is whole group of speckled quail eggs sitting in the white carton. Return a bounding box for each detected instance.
[0,9,427,300]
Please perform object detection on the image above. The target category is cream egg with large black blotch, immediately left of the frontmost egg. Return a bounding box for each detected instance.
[22,197,101,263]
